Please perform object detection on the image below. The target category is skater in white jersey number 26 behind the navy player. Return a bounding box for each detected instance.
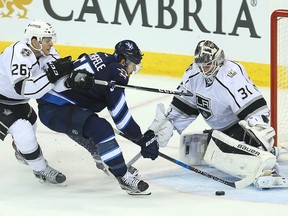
[0,20,91,184]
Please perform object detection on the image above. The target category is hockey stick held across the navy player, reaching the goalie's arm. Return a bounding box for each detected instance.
[94,80,193,96]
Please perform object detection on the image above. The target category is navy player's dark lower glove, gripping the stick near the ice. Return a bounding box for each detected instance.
[135,130,159,160]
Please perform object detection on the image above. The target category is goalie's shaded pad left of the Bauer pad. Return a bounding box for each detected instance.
[179,131,208,166]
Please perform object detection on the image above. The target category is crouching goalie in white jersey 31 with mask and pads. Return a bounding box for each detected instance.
[150,40,287,188]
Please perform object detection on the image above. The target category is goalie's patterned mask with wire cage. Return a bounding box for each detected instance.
[194,40,225,82]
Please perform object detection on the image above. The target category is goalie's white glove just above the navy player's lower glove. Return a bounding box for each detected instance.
[149,103,174,147]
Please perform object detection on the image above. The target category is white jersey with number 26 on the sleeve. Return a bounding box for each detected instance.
[0,41,59,105]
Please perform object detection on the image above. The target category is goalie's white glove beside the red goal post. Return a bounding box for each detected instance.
[239,120,275,152]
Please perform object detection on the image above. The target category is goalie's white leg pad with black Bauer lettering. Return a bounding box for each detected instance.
[204,130,276,180]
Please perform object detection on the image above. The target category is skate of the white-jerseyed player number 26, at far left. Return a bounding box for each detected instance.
[33,165,66,184]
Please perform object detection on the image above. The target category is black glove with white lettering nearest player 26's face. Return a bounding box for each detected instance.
[45,56,73,83]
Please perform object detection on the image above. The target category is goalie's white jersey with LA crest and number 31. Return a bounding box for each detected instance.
[167,60,270,133]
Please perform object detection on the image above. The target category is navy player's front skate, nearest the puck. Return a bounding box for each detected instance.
[116,171,151,195]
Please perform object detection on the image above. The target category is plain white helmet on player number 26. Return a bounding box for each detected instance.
[24,20,56,45]
